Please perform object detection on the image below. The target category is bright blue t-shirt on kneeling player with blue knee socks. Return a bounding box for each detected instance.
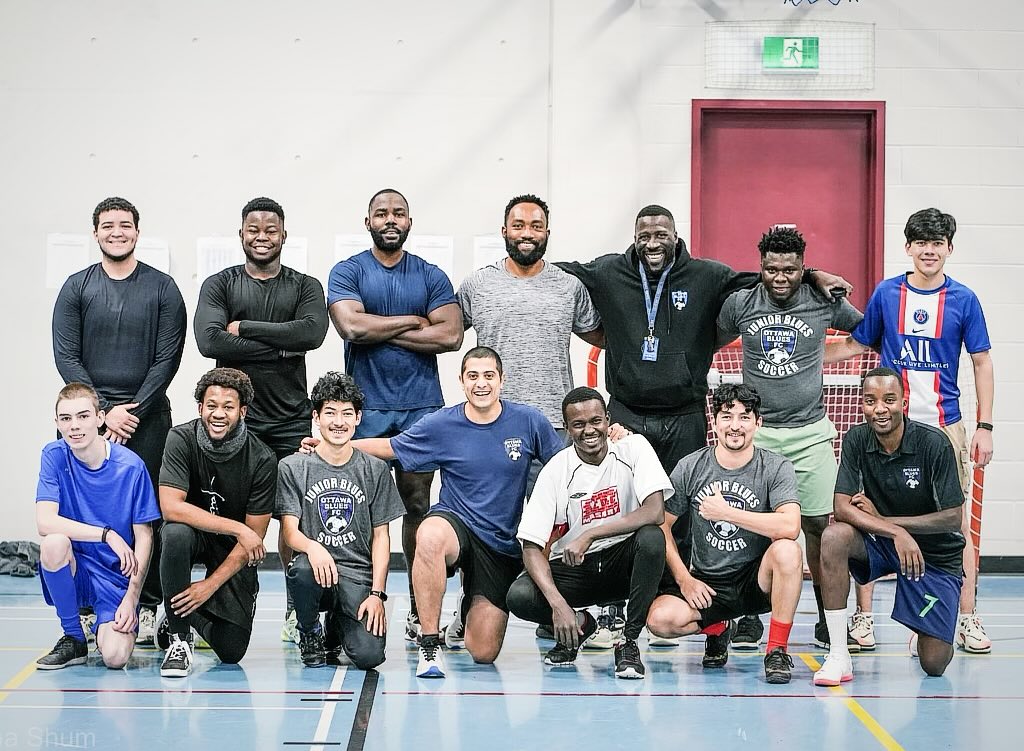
[36,441,160,591]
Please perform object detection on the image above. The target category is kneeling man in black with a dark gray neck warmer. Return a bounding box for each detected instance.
[157,368,278,678]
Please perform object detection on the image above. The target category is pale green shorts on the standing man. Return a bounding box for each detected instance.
[754,417,839,516]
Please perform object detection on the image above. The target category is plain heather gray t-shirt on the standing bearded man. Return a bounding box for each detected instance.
[457,260,601,427]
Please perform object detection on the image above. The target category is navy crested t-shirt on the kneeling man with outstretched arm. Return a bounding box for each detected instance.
[391,400,565,557]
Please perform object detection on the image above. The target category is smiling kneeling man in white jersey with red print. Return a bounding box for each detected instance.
[507,388,673,678]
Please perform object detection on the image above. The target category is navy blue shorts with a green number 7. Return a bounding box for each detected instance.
[850,535,964,644]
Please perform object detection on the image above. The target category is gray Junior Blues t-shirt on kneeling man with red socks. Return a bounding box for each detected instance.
[665,446,800,581]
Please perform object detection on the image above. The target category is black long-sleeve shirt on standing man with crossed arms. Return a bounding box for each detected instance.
[195,266,328,429]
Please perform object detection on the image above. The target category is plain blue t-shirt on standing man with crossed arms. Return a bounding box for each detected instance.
[327,250,457,410]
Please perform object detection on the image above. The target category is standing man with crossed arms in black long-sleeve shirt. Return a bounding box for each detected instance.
[195,198,328,643]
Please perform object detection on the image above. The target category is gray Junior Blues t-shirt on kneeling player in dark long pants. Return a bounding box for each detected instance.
[274,449,406,584]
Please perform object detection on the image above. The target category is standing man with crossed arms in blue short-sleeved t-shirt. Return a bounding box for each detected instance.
[328,189,463,641]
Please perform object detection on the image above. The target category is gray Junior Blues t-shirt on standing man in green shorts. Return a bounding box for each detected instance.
[718,284,863,427]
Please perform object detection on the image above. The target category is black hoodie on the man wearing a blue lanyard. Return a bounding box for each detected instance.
[557,240,761,414]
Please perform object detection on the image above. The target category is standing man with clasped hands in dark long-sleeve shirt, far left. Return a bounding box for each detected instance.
[53,197,186,644]
